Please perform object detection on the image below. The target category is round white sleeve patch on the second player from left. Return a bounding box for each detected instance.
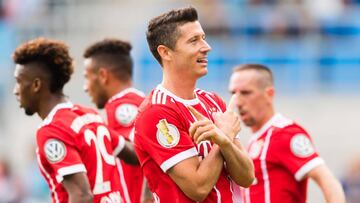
[115,104,138,126]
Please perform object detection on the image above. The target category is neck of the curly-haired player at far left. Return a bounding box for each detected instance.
[38,93,67,120]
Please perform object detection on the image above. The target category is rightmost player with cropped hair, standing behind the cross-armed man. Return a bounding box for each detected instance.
[229,64,345,203]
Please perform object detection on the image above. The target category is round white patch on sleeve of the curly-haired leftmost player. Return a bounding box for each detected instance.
[44,139,66,163]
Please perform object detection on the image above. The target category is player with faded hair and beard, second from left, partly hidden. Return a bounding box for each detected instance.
[84,39,152,203]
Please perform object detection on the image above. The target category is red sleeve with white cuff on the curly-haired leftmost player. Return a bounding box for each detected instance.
[37,126,86,183]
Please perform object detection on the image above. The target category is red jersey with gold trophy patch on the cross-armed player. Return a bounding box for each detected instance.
[135,85,232,203]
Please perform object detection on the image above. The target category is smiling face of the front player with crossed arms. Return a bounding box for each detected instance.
[171,21,211,78]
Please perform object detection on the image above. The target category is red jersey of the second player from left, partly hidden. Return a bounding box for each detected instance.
[105,88,145,203]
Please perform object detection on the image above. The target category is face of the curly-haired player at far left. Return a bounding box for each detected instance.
[13,64,37,116]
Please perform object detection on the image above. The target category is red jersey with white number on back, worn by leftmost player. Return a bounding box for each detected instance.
[36,102,125,203]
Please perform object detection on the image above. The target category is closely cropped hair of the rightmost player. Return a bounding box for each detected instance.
[233,63,274,87]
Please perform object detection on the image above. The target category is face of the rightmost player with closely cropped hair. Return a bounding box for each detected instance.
[229,70,270,130]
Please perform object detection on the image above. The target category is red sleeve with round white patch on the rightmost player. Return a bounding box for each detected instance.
[274,126,324,181]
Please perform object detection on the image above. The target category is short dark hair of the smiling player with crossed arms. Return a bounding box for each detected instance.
[146,7,198,64]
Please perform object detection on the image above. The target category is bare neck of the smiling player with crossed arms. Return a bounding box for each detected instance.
[161,69,196,99]
